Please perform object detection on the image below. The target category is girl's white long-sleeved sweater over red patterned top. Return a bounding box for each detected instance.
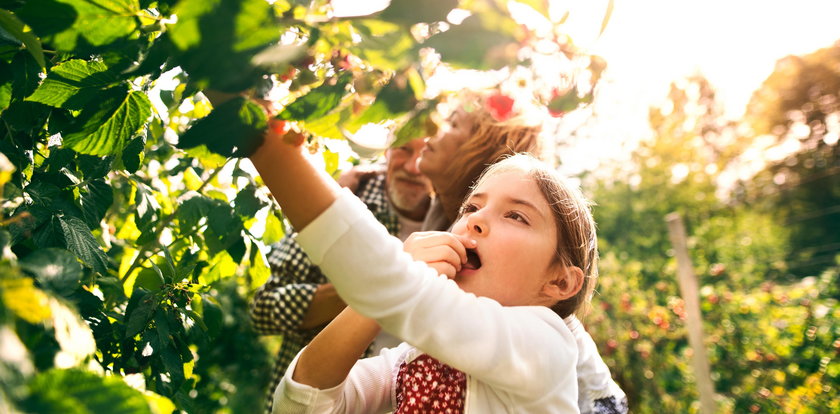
[274,191,578,413]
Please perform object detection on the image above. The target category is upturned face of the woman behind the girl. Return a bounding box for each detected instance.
[417,108,473,182]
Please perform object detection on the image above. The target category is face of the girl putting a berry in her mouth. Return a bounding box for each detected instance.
[452,170,561,306]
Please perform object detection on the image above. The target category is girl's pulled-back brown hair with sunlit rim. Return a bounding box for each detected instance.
[470,154,598,318]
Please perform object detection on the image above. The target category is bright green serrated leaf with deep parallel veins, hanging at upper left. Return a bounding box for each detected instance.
[64,87,152,155]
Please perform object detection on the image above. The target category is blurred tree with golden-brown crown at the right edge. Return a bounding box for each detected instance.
[738,43,840,277]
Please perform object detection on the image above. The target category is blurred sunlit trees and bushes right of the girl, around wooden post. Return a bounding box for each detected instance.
[584,43,840,413]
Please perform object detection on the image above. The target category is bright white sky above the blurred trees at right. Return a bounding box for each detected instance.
[555,0,840,172]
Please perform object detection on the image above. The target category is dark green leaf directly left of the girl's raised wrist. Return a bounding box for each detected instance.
[178,97,268,156]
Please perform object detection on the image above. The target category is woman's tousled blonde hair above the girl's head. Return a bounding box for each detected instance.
[435,93,541,219]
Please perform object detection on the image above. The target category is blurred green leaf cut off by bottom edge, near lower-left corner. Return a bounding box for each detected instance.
[21,368,151,414]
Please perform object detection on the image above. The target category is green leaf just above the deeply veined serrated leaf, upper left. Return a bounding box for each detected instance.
[26,59,119,109]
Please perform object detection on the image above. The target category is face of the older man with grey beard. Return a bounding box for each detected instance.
[386,138,432,219]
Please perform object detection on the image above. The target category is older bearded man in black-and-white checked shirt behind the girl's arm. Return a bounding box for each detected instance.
[251,139,432,412]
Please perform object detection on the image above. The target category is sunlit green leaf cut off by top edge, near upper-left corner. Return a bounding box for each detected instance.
[18,0,140,52]
